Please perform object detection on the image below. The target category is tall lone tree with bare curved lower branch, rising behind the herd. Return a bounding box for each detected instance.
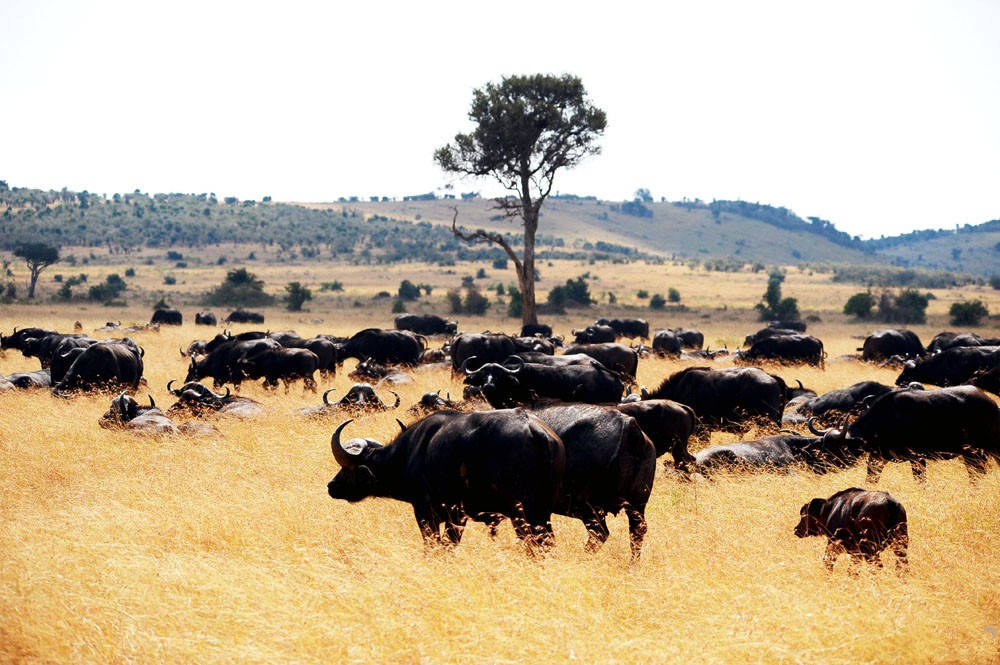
[434,74,607,323]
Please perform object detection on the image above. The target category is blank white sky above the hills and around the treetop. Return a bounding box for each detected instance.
[0,0,1000,237]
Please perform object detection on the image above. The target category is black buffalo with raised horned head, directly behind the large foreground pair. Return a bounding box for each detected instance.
[464,356,625,408]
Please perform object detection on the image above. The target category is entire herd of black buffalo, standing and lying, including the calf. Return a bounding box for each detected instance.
[0,316,1000,568]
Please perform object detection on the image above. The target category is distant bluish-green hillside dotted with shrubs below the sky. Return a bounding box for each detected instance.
[0,181,1000,277]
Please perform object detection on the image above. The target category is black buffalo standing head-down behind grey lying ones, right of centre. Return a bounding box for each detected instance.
[643,367,788,432]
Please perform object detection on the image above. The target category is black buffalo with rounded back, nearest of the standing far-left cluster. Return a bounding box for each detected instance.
[52,337,144,396]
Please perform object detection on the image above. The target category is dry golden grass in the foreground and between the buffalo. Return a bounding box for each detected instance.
[0,304,1000,664]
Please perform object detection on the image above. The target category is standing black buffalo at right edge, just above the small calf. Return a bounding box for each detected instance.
[809,386,1000,484]
